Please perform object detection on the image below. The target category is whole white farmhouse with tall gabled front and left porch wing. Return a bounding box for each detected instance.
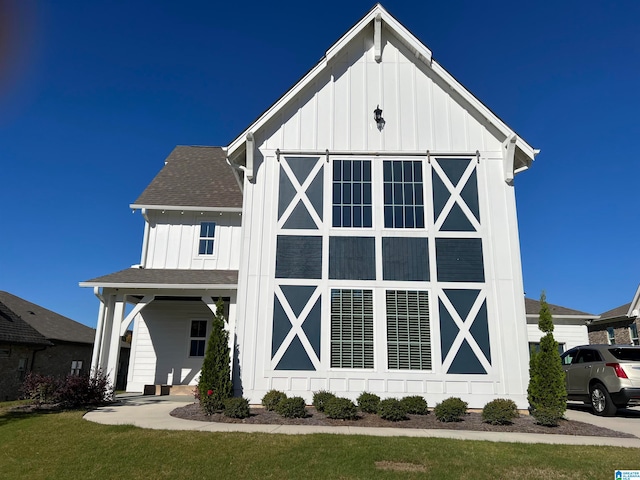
[80,5,537,408]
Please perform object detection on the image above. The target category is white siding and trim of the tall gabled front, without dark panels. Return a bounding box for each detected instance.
[231,21,528,408]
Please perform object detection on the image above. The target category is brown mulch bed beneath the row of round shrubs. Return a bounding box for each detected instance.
[171,403,636,438]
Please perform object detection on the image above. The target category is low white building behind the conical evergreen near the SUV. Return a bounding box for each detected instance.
[524,298,598,352]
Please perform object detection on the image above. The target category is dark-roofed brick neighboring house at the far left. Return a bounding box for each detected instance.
[0,291,95,400]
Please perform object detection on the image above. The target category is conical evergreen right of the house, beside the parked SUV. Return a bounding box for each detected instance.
[527,292,567,426]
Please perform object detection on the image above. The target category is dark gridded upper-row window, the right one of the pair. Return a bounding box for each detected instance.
[383,160,424,228]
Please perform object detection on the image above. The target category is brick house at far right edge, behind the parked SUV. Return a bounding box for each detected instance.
[588,286,640,345]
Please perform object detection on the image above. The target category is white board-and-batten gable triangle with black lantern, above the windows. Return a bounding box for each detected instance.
[255,26,504,156]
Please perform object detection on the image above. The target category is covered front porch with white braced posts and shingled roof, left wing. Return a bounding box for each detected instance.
[80,268,238,394]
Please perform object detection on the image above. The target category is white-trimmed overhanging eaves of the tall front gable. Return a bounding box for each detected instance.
[227,3,538,173]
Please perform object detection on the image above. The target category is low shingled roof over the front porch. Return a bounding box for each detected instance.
[80,268,238,287]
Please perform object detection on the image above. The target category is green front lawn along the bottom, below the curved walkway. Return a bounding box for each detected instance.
[0,404,640,480]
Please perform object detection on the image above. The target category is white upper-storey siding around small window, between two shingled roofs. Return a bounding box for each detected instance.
[145,211,242,270]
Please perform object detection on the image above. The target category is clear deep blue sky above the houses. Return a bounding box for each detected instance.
[0,0,640,326]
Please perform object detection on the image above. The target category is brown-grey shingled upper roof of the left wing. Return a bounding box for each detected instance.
[133,146,242,208]
